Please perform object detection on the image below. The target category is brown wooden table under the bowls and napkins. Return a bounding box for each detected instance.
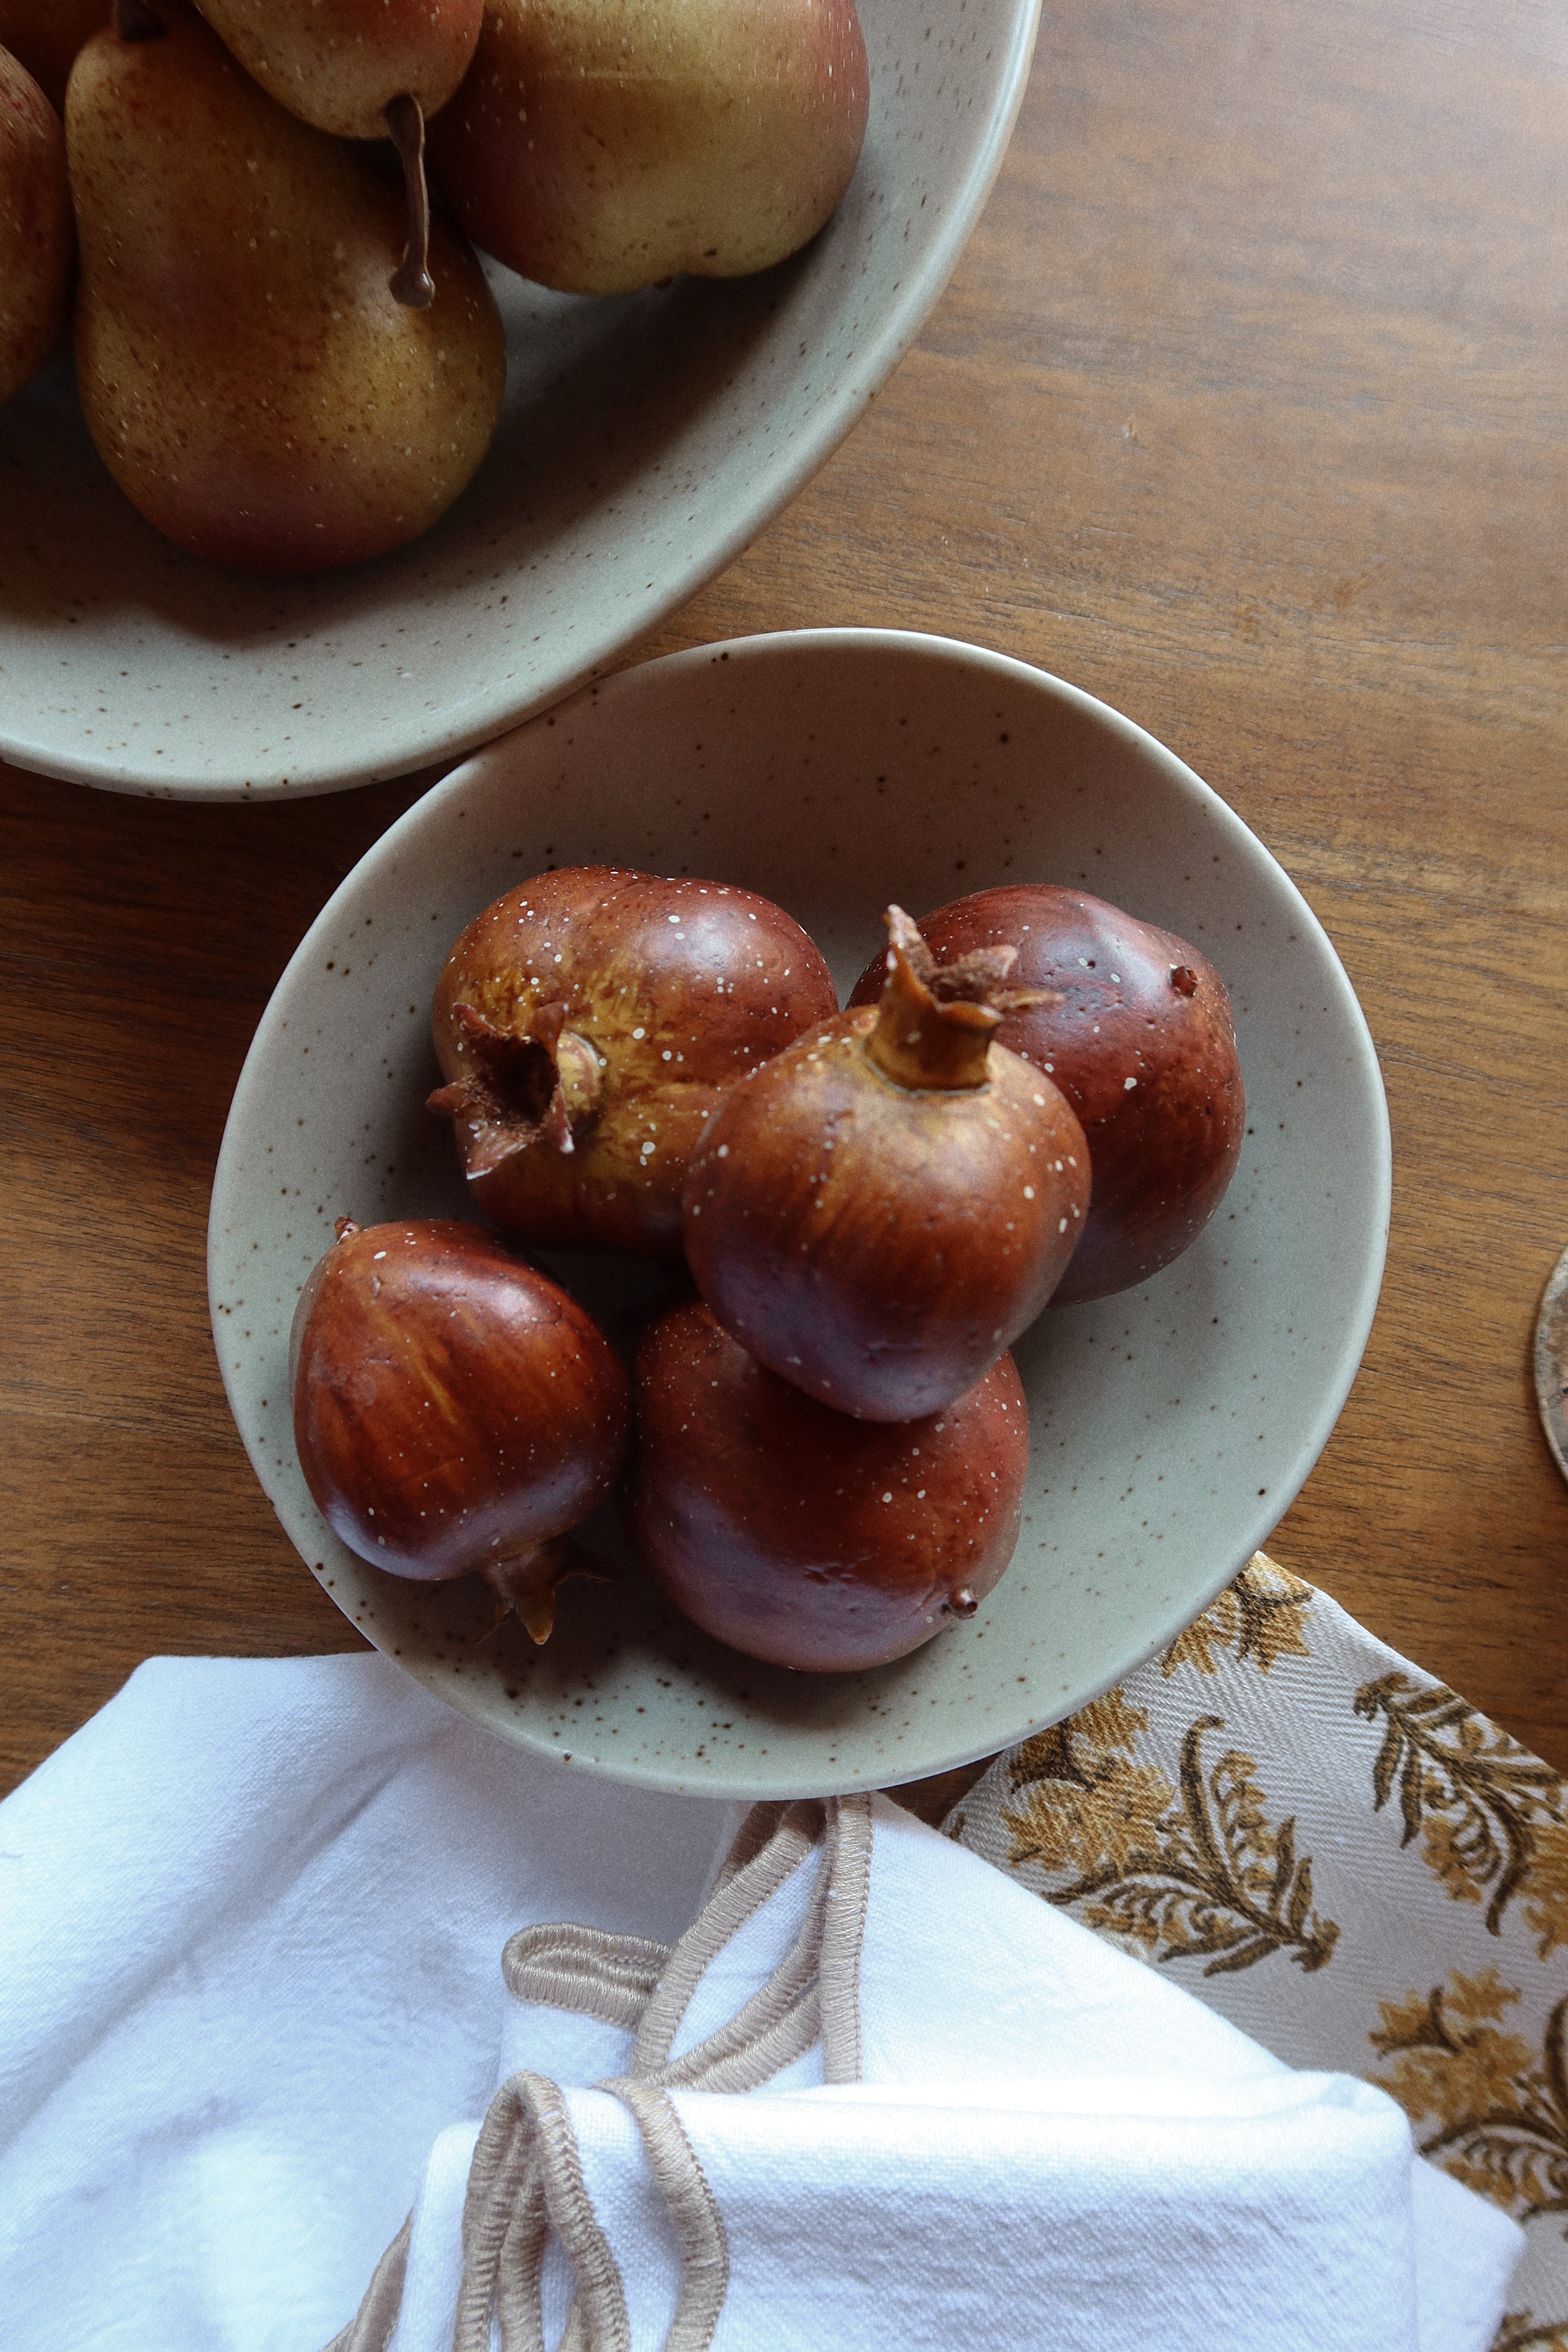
[0,0,1568,1785]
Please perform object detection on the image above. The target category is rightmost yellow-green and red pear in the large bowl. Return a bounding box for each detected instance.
[430,0,867,294]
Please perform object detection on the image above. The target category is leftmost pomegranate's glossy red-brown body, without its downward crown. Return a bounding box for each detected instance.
[289,1218,630,1580]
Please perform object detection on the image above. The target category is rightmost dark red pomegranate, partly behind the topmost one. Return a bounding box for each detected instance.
[848,882,1246,1305]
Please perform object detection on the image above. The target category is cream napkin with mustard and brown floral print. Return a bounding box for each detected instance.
[943,1553,1568,2352]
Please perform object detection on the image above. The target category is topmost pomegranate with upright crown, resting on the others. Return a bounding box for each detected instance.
[686,908,1088,1421]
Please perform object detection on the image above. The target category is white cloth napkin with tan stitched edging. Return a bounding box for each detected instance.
[0,1654,1521,2352]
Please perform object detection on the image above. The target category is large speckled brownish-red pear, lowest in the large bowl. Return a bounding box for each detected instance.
[66,0,505,572]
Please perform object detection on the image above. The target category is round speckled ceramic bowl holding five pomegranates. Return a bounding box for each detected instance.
[209,630,1389,1797]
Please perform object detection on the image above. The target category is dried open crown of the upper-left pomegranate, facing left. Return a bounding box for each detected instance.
[426,1004,602,1181]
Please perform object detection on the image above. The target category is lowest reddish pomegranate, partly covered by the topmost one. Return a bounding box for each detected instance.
[628,1301,1030,1675]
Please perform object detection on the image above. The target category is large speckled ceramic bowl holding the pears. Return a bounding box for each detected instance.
[0,0,1039,799]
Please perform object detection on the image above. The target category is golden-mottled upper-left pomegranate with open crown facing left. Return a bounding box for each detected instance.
[430,866,839,1254]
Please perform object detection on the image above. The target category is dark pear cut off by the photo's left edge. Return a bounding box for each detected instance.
[0,49,75,400]
